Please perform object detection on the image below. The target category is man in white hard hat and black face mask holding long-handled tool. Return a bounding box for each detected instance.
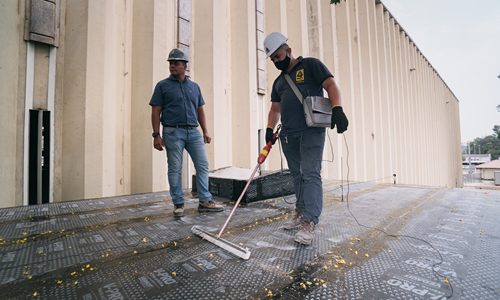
[264,32,349,245]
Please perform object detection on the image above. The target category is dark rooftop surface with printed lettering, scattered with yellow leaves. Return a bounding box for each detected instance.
[0,182,500,300]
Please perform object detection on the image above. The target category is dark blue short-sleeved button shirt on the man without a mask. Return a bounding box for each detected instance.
[149,75,205,126]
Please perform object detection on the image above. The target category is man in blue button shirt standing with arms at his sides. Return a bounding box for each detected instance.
[149,48,224,217]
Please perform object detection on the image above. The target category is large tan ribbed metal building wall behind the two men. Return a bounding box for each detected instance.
[0,0,462,207]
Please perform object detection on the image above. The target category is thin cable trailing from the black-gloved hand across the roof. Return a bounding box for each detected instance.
[342,133,454,299]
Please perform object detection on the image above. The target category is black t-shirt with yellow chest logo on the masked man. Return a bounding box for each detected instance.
[271,57,333,134]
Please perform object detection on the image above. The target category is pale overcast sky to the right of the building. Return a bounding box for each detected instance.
[382,0,500,142]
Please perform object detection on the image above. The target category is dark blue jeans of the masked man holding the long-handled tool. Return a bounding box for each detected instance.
[280,128,325,224]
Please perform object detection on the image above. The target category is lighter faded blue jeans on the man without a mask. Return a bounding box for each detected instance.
[163,127,212,205]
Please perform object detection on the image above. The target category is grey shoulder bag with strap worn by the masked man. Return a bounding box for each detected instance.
[285,74,332,127]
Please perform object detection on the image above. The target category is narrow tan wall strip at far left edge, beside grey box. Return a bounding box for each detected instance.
[0,1,26,207]
